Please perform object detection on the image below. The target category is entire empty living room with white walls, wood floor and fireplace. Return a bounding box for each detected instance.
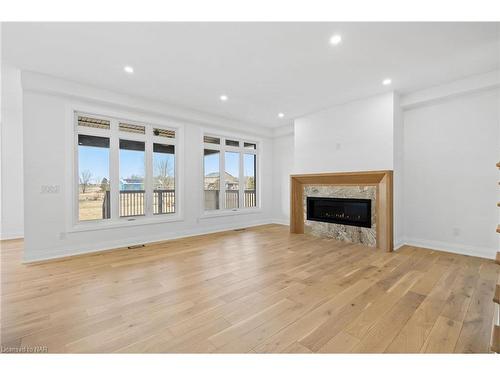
[1,1,500,374]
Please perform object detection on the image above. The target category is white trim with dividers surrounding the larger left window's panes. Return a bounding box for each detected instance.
[66,105,184,233]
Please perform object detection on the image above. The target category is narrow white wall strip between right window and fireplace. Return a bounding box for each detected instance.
[273,133,294,225]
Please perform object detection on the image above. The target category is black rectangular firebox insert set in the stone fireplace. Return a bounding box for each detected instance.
[307,197,372,228]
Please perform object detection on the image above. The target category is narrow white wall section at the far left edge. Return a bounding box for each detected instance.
[0,64,24,239]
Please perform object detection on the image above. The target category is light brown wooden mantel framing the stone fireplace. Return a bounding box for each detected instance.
[290,171,394,251]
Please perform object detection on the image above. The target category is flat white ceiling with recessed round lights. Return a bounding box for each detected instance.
[2,23,500,127]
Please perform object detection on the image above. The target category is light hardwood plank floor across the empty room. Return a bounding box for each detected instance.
[1,225,500,353]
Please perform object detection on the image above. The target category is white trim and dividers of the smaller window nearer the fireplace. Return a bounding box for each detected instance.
[200,129,263,219]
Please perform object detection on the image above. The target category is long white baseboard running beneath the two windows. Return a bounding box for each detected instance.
[23,220,273,264]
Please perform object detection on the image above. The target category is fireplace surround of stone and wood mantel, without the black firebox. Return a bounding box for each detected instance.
[290,171,394,251]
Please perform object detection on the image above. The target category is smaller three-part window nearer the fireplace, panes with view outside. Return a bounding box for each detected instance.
[203,135,258,211]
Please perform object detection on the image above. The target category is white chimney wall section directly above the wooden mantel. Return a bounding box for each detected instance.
[294,92,394,173]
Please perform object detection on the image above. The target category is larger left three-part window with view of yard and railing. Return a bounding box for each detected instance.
[75,114,177,222]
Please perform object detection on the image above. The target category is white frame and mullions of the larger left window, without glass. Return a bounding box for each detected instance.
[71,108,183,232]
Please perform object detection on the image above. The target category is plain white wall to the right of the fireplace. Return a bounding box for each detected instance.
[404,90,500,258]
